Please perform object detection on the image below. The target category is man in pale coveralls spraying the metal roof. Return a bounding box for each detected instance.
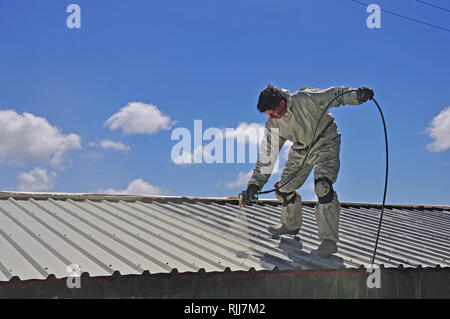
[243,85,374,258]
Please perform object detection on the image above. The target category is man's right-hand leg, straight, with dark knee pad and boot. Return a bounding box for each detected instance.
[313,135,341,258]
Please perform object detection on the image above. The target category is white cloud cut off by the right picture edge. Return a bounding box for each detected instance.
[426,106,450,152]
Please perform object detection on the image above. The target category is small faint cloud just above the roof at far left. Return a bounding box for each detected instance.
[17,167,56,192]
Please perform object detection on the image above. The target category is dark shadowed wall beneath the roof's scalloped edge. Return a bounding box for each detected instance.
[0,268,450,299]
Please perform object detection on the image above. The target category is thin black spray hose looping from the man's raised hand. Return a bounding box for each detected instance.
[256,90,389,265]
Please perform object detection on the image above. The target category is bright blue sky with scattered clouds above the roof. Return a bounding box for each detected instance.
[0,0,450,205]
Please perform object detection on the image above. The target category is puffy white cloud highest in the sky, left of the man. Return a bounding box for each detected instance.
[104,102,175,135]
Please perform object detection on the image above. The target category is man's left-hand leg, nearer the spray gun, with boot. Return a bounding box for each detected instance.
[268,144,313,235]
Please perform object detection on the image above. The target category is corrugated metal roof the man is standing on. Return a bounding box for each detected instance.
[0,193,450,281]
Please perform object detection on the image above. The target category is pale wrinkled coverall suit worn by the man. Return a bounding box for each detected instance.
[248,87,361,242]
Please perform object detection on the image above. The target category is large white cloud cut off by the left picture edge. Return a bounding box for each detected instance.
[0,110,81,169]
